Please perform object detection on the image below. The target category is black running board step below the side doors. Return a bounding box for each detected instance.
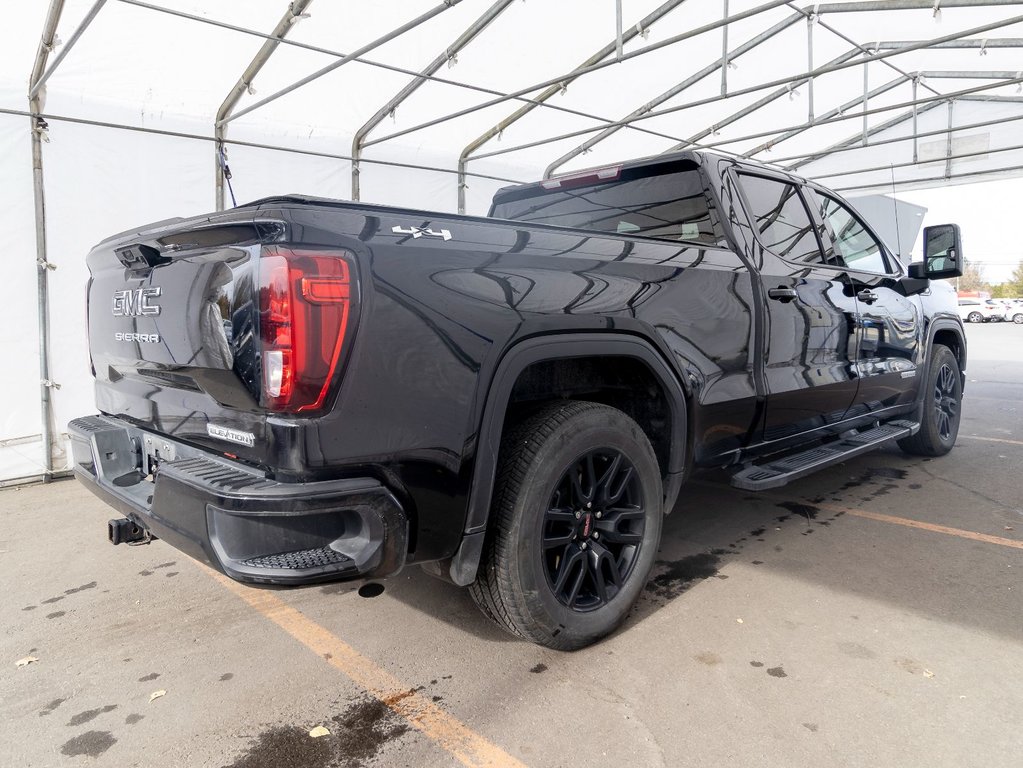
[731,420,920,491]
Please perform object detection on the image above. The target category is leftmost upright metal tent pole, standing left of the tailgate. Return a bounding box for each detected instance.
[29,0,68,481]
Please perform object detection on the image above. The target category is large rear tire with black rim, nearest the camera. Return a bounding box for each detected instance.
[470,401,664,650]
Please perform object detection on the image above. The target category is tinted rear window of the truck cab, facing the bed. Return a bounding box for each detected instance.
[490,160,724,245]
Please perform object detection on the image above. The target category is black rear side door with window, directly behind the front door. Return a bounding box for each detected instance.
[737,171,857,441]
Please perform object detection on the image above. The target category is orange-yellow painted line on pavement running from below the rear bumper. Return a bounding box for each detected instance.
[203,566,525,768]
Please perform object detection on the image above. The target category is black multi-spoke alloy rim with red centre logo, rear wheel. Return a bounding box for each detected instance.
[541,448,646,612]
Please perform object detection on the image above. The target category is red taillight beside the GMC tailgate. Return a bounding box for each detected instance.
[259,247,352,412]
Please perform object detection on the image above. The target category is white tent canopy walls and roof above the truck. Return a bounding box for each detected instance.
[0,0,1023,483]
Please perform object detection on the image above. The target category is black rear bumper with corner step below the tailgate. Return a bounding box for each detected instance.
[69,416,408,585]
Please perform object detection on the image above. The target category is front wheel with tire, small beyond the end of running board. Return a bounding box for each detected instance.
[898,344,963,456]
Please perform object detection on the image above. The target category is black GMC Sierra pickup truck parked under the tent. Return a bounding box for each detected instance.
[71,152,967,648]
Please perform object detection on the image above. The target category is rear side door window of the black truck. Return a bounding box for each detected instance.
[739,174,821,264]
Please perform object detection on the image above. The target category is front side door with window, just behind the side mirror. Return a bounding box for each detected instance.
[807,189,923,415]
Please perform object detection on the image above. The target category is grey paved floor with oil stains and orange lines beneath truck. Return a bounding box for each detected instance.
[0,325,1023,768]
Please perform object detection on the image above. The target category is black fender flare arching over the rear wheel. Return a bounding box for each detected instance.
[448,333,687,586]
